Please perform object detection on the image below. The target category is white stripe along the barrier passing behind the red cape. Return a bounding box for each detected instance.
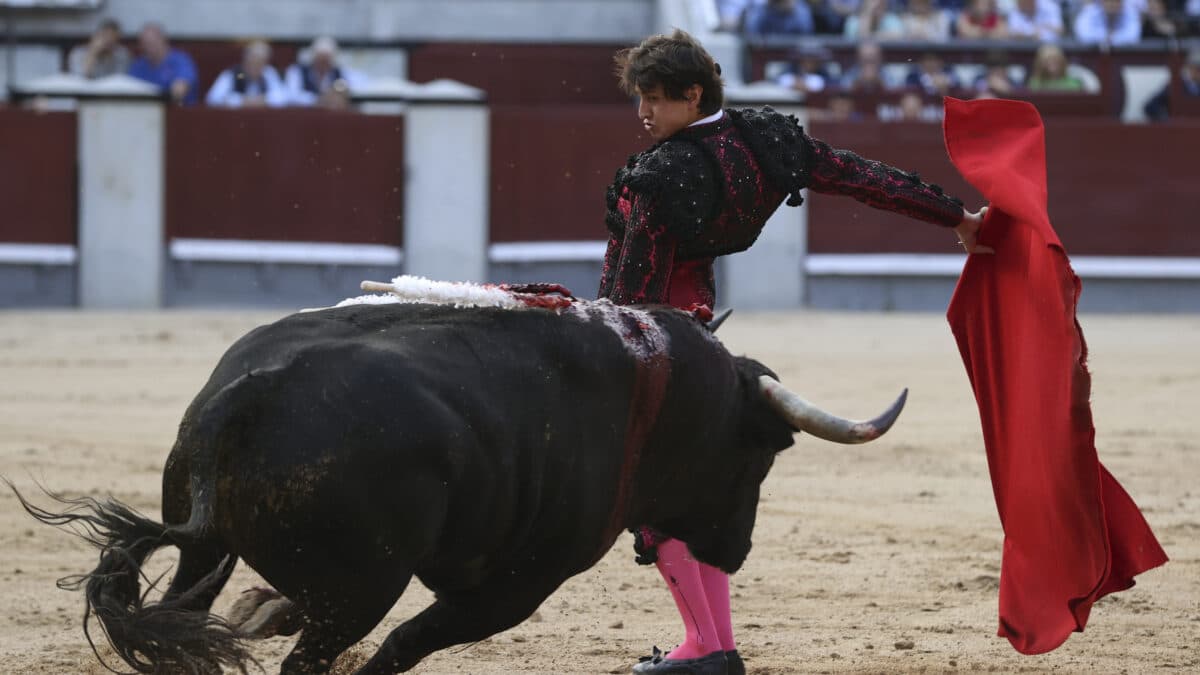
[804,253,1200,279]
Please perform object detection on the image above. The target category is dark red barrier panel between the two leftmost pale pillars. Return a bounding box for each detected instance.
[166,108,404,245]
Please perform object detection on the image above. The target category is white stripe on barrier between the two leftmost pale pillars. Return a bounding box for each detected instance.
[169,239,403,265]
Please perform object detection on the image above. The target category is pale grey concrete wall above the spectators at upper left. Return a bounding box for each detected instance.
[4,0,655,42]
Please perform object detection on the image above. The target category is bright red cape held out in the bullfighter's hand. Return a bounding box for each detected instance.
[944,98,1166,653]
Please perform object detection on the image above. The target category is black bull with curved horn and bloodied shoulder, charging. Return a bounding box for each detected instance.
[7,301,902,673]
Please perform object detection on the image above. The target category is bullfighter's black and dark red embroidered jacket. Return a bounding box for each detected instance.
[600,107,962,307]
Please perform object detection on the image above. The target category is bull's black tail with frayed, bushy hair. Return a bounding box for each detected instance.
[0,478,253,674]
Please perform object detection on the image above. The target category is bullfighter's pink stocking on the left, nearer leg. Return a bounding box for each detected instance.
[655,539,728,658]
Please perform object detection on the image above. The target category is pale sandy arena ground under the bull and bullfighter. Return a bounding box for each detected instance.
[0,312,1200,674]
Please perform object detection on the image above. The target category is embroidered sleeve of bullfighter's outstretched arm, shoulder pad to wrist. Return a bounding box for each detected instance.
[809,137,964,227]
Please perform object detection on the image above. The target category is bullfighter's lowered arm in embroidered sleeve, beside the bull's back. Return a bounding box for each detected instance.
[601,195,676,305]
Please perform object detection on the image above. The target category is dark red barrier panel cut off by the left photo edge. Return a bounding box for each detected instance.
[0,108,78,244]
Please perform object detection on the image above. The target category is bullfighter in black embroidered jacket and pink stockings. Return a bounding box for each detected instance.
[600,30,986,675]
